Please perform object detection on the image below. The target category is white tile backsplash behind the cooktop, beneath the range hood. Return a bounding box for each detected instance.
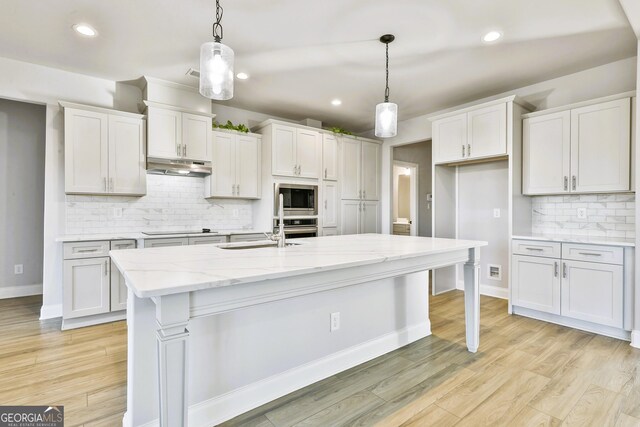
[65,175,252,234]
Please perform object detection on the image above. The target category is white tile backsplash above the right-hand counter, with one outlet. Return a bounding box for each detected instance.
[531,193,636,239]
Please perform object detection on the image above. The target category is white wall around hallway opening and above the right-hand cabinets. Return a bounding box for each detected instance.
[378,57,638,233]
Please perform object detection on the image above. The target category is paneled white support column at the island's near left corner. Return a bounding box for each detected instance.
[155,293,189,427]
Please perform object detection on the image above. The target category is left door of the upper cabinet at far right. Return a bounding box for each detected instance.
[522,111,571,194]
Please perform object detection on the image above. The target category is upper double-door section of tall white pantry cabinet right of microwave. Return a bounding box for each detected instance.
[340,138,381,200]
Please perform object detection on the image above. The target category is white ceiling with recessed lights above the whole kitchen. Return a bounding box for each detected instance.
[0,0,636,131]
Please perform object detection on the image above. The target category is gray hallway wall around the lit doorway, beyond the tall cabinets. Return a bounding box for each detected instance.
[393,140,431,237]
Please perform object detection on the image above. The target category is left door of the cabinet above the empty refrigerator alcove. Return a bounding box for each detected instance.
[432,113,467,163]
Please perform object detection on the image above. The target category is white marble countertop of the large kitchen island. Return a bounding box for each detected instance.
[110,234,487,298]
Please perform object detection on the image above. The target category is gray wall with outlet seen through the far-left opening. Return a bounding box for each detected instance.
[0,99,46,288]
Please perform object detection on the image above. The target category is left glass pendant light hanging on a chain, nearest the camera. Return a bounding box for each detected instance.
[200,0,234,101]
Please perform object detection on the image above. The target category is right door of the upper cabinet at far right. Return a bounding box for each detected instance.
[571,98,631,193]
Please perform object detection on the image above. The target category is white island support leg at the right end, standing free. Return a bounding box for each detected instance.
[464,248,480,353]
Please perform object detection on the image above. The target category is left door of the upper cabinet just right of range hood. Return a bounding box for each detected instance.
[210,132,237,197]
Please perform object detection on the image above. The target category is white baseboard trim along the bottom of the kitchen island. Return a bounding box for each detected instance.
[128,320,431,427]
